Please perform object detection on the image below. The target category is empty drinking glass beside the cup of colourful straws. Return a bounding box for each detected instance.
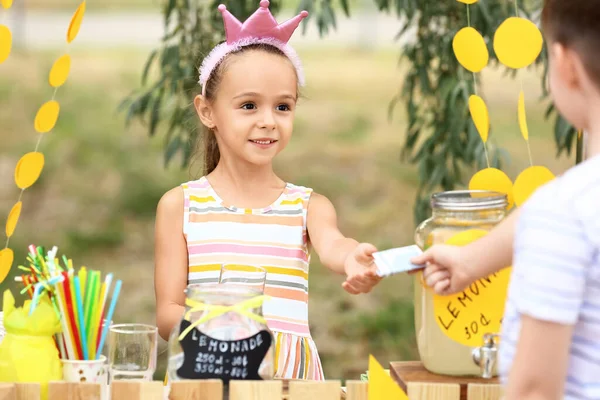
[108,324,158,382]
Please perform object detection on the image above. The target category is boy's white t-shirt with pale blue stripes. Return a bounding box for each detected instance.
[499,156,600,400]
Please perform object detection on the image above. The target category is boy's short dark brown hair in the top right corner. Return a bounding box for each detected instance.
[542,0,600,87]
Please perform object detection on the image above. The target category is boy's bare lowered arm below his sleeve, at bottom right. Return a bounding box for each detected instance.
[506,315,573,400]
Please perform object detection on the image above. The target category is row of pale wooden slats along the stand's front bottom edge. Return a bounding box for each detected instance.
[0,380,501,400]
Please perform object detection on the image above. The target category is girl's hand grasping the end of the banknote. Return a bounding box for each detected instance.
[342,243,381,294]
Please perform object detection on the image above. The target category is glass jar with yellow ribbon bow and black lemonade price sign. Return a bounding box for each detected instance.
[167,278,275,385]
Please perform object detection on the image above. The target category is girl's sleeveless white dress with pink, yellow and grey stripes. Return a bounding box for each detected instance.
[182,177,324,380]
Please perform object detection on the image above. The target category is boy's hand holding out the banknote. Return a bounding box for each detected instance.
[411,245,475,296]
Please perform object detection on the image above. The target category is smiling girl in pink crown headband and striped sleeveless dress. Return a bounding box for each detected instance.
[154,0,380,380]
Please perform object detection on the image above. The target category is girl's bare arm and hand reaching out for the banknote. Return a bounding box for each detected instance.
[306,193,381,294]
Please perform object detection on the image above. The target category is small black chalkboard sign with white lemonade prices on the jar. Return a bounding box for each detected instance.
[177,320,272,383]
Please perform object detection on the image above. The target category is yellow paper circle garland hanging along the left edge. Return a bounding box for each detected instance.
[0,0,85,283]
